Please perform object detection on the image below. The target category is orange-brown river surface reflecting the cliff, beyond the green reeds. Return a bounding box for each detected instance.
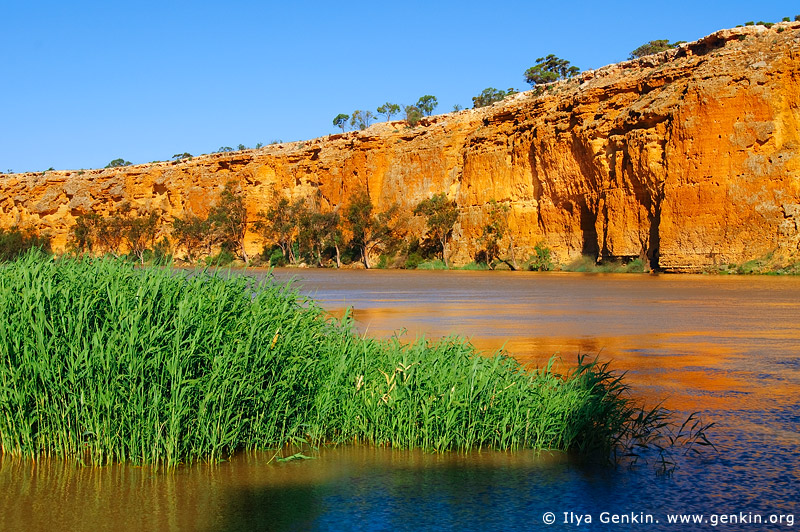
[276,270,800,410]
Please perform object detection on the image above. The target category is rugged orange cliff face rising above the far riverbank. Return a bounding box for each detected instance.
[0,23,800,271]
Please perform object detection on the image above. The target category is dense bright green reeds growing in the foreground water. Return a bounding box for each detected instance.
[0,255,704,465]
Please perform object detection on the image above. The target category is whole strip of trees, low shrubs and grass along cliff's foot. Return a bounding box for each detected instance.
[0,194,800,275]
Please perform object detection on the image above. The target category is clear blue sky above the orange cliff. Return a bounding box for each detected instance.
[0,0,800,172]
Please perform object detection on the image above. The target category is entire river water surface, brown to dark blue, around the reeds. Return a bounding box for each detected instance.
[0,270,800,532]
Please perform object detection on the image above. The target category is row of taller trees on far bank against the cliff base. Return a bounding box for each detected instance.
[69,182,520,269]
